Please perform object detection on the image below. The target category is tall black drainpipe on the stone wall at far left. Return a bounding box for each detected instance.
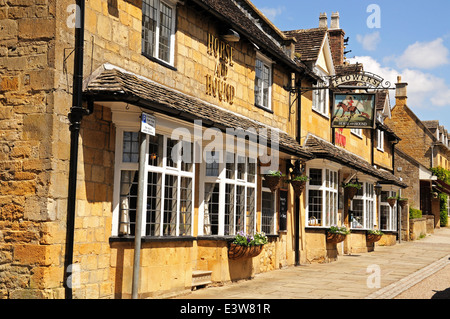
[64,0,92,299]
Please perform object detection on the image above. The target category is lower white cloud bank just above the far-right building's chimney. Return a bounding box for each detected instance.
[348,56,450,109]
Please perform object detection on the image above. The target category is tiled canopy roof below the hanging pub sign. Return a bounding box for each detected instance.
[305,134,408,187]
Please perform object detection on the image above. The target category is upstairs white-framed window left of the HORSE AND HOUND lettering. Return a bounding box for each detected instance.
[142,0,175,65]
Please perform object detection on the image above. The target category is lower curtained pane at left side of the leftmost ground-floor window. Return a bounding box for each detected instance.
[119,171,138,236]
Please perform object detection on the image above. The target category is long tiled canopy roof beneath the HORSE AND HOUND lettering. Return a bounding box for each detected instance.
[83,64,313,159]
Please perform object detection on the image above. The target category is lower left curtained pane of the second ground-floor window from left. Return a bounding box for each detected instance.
[203,183,219,235]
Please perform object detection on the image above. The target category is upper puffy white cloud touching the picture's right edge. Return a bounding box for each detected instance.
[397,38,449,69]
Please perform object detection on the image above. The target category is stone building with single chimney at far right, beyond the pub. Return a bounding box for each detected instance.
[386,77,450,231]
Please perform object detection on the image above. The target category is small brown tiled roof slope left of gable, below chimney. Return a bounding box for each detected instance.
[284,28,327,62]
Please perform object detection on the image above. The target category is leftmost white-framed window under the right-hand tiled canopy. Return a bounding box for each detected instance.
[306,168,339,227]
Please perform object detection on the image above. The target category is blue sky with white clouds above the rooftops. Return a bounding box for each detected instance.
[252,0,450,132]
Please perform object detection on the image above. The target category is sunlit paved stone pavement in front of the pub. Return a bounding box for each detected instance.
[174,227,450,299]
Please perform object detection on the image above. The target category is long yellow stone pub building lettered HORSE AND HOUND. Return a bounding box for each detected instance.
[0,0,406,299]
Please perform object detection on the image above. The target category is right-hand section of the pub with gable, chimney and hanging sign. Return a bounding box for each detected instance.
[285,12,406,262]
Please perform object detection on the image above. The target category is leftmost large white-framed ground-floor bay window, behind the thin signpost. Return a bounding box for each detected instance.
[113,128,194,236]
